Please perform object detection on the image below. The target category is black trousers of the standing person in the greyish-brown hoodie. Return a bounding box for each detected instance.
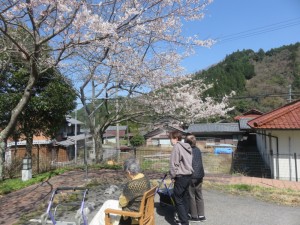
[173,176,191,225]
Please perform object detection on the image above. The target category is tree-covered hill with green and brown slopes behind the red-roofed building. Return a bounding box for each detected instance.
[193,42,300,116]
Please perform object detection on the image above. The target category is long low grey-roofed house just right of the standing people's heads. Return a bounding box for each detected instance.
[186,123,245,147]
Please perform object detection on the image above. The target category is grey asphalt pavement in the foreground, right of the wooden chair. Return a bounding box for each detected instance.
[156,190,300,225]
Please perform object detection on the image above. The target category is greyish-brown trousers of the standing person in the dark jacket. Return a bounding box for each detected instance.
[189,178,204,218]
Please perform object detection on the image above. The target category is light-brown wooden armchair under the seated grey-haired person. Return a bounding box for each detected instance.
[105,186,157,225]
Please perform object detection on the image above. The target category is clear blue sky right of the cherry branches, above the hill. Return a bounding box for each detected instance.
[182,0,300,73]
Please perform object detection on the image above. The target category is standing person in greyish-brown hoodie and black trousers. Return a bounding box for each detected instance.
[169,131,193,225]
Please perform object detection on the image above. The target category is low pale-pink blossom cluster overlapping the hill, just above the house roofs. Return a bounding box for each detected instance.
[145,76,235,124]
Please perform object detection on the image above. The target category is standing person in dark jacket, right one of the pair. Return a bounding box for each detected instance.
[185,135,206,222]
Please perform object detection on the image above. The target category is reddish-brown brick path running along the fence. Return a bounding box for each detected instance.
[0,170,300,225]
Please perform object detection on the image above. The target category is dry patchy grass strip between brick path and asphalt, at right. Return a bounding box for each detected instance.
[203,181,300,206]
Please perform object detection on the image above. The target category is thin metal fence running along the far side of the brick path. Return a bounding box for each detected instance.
[4,147,300,181]
